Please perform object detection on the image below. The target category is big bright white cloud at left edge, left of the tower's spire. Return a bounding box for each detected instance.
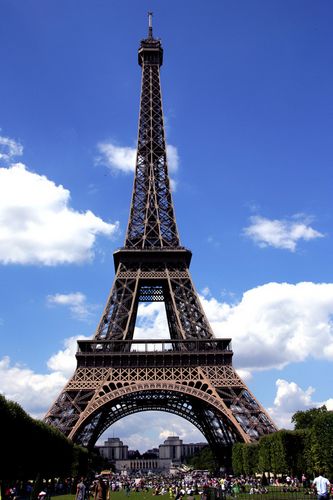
[0,163,118,265]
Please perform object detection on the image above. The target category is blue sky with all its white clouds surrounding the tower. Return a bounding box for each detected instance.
[0,0,333,450]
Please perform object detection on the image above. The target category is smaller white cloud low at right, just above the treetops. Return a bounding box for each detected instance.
[268,379,333,429]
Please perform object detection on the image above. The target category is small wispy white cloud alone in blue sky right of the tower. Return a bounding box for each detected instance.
[243,215,324,252]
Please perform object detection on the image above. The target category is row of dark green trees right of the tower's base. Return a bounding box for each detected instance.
[232,406,333,477]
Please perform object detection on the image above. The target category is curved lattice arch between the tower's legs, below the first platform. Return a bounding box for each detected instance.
[69,382,246,450]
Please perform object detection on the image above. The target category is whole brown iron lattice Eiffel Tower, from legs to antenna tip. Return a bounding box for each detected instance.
[45,13,277,459]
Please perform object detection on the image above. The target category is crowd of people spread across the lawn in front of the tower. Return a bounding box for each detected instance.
[3,472,333,500]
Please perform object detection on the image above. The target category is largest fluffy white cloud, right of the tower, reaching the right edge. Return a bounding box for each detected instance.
[198,282,333,372]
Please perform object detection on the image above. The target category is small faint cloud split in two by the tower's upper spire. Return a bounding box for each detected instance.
[97,141,179,177]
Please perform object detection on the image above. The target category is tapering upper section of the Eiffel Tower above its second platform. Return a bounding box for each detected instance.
[125,12,176,249]
